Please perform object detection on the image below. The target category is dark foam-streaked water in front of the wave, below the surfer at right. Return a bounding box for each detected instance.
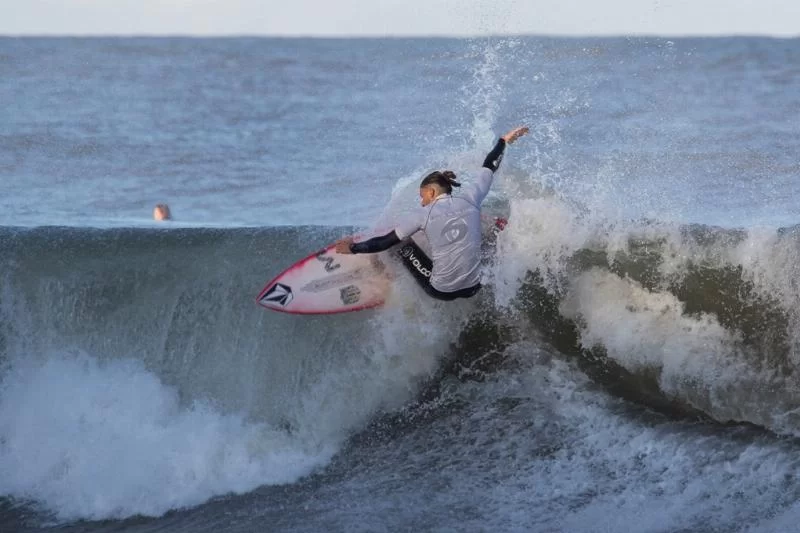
[352,350,798,533]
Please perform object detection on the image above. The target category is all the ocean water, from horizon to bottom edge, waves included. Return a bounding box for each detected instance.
[0,37,800,532]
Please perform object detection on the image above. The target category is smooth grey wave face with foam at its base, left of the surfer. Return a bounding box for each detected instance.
[0,223,450,522]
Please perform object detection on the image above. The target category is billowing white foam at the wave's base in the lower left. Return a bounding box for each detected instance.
[0,355,335,519]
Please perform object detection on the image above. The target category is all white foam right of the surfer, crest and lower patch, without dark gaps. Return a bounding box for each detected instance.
[478,189,800,435]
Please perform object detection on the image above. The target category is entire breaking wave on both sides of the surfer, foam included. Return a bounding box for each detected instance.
[0,210,800,519]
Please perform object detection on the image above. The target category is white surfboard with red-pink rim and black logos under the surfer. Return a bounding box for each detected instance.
[256,217,506,315]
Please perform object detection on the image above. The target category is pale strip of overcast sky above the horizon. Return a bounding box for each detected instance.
[0,0,800,37]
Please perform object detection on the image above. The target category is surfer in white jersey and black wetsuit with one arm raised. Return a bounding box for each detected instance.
[336,126,528,300]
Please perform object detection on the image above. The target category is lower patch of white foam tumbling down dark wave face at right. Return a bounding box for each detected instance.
[560,269,797,431]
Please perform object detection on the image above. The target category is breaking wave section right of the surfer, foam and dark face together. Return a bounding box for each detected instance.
[493,197,800,435]
